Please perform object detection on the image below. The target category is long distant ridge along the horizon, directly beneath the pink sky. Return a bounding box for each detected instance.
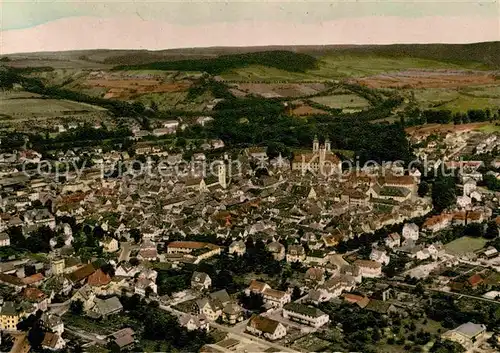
[7,42,500,70]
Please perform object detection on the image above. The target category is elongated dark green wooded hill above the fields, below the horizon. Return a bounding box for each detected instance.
[115,51,317,75]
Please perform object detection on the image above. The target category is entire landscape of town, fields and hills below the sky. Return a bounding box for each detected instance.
[0,2,500,353]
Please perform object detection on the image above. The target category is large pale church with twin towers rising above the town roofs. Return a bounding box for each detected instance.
[292,136,342,176]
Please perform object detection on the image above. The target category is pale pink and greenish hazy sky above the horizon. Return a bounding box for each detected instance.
[0,0,500,54]
